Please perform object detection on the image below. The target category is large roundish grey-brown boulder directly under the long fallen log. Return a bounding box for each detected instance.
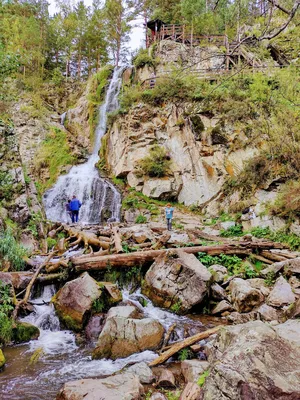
[142,251,211,313]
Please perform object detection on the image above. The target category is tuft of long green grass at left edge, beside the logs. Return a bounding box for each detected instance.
[0,229,27,271]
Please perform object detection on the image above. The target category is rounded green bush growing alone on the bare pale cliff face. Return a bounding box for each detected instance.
[138,145,171,177]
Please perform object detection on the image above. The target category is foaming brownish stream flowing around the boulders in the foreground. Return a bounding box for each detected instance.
[0,285,220,400]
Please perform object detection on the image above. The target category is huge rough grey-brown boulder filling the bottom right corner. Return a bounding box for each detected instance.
[203,321,300,400]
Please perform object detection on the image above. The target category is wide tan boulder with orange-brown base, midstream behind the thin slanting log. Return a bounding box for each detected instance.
[93,307,164,360]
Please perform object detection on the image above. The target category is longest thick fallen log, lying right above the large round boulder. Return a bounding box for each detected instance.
[71,242,283,271]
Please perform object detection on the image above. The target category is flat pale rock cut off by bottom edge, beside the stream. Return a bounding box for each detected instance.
[56,373,144,400]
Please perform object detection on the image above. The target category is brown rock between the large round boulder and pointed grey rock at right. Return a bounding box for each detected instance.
[229,278,264,312]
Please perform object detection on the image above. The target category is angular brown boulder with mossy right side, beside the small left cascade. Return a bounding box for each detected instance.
[52,272,101,331]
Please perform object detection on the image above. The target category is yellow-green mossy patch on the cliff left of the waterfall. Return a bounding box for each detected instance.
[35,127,76,191]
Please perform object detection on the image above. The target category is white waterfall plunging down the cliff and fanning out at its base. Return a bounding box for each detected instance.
[44,68,123,224]
